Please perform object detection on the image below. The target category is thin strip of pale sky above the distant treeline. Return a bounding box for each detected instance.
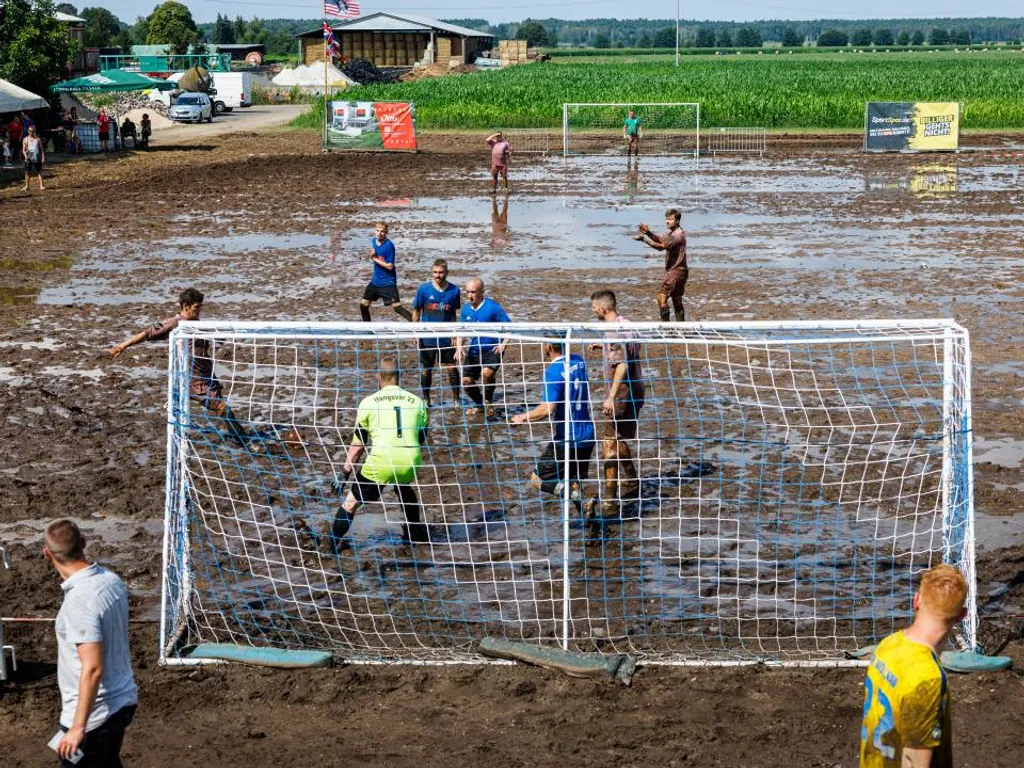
[92,0,1021,23]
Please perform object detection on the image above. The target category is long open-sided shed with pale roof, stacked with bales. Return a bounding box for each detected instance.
[297,12,495,67]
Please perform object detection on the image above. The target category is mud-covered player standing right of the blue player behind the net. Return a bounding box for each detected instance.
[588,290,645,517]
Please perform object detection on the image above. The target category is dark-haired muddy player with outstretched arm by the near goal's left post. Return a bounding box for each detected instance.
[111,288,249,445]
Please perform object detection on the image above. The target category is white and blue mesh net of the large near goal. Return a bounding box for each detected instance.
[161,321,976,664]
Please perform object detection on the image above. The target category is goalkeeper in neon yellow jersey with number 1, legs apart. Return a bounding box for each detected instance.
[331,357,427,543]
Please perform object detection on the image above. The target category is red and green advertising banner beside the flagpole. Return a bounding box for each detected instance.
[325,101,416,152]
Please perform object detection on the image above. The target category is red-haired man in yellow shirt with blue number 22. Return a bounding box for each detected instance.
[860,565,968,768]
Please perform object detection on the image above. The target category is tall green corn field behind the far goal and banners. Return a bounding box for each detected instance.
[311,51,1024,129]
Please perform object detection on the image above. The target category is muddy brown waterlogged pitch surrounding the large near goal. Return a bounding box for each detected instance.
[0,132,1024,766]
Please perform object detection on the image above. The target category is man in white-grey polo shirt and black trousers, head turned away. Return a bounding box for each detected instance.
[43,520,137,768]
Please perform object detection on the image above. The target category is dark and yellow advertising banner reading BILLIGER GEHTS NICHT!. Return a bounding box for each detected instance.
[864,101,961,152]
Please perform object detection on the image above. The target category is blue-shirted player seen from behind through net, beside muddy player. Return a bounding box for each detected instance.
[512,342,594,509]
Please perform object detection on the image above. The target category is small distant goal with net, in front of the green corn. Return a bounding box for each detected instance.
[562,103,700,157]
